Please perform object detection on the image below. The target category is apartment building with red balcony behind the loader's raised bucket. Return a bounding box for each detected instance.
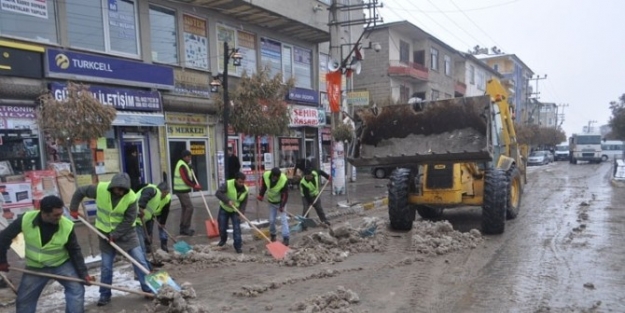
[354,21,467,105]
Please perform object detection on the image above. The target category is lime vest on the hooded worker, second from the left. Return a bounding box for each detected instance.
[95,182,137,233]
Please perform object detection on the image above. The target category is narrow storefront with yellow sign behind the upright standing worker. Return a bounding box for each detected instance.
[165,112,215,192]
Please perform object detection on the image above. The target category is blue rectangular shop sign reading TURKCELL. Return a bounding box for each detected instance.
[45,48,174,89]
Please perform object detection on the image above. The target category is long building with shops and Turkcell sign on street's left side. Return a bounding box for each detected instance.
[0,0,329,191]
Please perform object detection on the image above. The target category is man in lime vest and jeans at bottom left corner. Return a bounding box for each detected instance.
[0,196,94,313]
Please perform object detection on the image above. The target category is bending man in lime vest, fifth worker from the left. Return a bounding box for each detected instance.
[215,172,248,253]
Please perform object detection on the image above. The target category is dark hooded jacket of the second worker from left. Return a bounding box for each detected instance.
[69,173,139,252]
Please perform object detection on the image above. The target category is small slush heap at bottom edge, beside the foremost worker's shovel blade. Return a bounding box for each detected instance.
[148,282,209,313]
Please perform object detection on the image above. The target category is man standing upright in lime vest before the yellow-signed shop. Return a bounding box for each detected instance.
[174,150,202,236]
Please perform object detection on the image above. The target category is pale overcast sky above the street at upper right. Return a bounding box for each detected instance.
[380,0,625,136]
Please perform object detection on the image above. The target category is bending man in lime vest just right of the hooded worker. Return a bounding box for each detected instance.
[137,182,171,253]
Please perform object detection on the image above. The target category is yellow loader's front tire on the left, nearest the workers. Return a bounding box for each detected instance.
[388,168,416,230]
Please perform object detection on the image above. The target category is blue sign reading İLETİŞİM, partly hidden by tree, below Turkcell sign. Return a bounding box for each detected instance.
[50,83,163,112]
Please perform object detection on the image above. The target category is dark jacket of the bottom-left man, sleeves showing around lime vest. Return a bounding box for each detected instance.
[0,214,89,278]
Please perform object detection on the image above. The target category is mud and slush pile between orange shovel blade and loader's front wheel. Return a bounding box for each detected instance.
[281,218,387,267]
